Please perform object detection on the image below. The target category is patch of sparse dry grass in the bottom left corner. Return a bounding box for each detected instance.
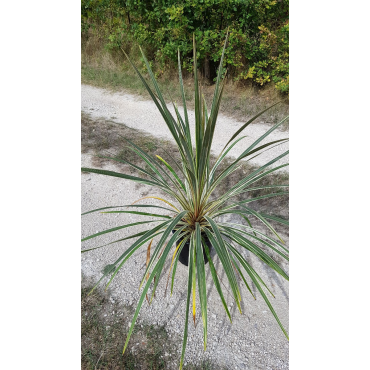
[81,280,175,370]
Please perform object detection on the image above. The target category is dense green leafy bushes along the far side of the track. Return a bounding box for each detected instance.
[81,0,289,93]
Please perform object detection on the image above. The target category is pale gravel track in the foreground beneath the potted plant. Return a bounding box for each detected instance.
[81,154,289,370]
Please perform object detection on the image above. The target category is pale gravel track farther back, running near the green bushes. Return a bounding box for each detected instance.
[81,85,289,171]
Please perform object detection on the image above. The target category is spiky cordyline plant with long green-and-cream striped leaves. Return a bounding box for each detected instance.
[82,34,288,369]
